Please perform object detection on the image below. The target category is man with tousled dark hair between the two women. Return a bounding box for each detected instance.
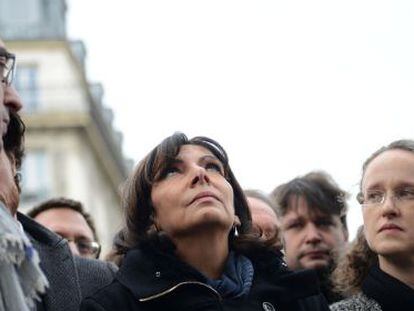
[272,172,348,303]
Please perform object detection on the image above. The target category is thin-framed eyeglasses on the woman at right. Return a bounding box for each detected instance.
[357,187,414,206]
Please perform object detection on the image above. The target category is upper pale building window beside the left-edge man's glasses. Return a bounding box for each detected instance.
[15,65,39,112]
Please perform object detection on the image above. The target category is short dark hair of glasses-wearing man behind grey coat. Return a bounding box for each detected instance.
[27,197,99,242]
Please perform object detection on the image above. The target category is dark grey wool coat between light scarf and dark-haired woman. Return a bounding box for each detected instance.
[17,213,116,311]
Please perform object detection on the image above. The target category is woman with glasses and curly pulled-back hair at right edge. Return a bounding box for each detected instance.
[331,140,414,311]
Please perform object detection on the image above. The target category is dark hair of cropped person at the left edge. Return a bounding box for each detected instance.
[3,111,26,192]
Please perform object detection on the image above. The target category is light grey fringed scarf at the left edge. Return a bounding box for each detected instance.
[0,203,48,311]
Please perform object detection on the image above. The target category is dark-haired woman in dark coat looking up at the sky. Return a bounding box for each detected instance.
[81,133,329,311]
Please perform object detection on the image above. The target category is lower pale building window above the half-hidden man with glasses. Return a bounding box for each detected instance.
[22,150,50,202]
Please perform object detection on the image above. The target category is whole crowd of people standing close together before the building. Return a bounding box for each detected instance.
[0,39,414,311]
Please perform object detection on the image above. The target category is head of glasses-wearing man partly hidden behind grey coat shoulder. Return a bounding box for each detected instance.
[27,198,101,258]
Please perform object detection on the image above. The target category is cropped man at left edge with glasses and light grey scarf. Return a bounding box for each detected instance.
[0,40,48,311]
